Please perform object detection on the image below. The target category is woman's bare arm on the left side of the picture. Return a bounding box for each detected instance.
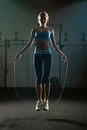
[15,29,35,60]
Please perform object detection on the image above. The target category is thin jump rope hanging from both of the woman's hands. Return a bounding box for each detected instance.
[14,54,68,106]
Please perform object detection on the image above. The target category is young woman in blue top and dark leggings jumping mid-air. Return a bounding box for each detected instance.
[15,11,67,111]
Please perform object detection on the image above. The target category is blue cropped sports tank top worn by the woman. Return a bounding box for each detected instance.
[35,30,51,42]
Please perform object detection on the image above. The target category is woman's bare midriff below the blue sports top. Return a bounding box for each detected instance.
[36,41,50,50]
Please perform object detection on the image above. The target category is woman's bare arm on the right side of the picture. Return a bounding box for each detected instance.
[51,29,67,61]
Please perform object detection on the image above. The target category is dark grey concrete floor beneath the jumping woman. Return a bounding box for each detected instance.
[0,88,87,130]
